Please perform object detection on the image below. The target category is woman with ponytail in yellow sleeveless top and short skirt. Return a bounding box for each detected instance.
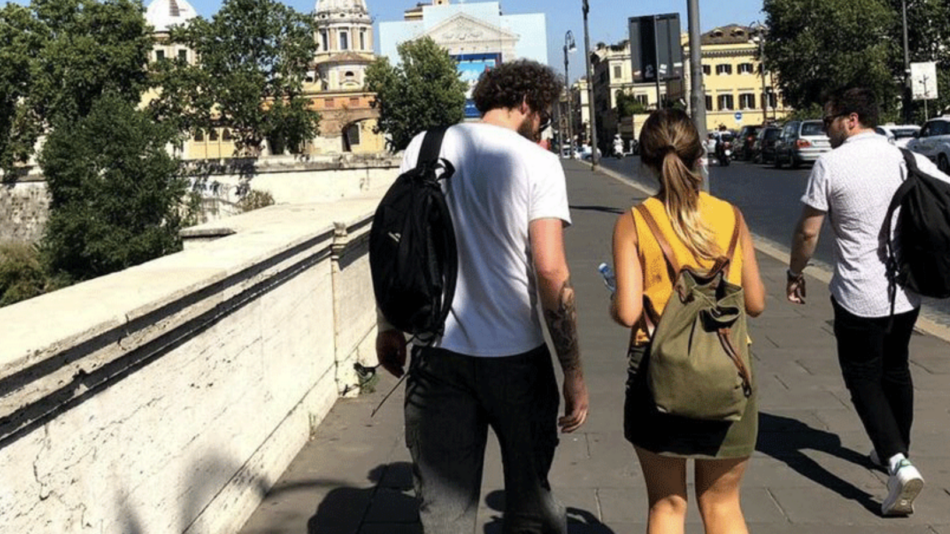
[611,110,765,534]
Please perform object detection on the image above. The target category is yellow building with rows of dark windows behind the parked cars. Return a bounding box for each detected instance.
[684,24,792,130]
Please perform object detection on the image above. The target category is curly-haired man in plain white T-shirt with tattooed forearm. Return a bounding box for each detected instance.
[376,60,588,534]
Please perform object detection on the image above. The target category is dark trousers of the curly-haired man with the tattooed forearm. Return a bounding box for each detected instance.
[405,346,567,534]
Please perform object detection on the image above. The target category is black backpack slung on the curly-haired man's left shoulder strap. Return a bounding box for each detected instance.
[369,128,458,341]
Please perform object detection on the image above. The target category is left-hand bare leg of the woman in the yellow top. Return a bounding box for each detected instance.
[634,447,687,534]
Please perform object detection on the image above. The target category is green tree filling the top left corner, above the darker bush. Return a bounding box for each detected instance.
[0,0,152,176]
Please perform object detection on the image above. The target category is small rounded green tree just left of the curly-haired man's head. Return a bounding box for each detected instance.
[366,37,466,152]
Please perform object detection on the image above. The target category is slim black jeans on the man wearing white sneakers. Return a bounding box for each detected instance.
[831,298,920,462]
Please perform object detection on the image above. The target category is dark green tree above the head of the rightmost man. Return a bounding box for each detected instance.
[763,0,900,111]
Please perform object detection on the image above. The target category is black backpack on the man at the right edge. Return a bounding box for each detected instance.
[882,149,950,315]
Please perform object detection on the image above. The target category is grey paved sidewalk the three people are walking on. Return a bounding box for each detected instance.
[236,162,950,534]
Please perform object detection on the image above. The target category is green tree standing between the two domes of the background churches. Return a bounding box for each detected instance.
[150,0,320,155]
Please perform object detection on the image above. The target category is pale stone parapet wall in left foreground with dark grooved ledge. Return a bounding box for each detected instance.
[0,199,376,534]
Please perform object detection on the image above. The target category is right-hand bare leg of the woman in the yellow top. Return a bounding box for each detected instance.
[696,457,749,534]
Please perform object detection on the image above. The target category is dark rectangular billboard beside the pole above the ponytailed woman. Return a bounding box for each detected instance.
[629,13,683,82]
